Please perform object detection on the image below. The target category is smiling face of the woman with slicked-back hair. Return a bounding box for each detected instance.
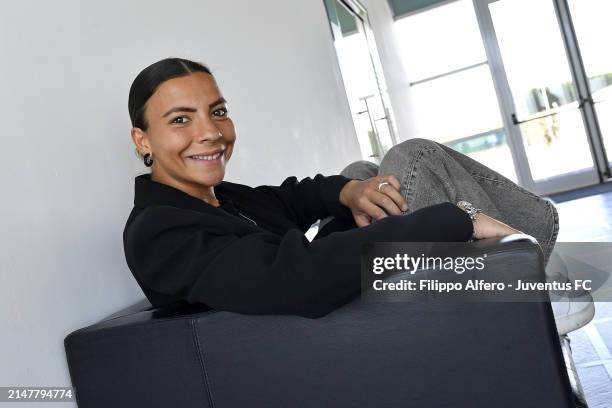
[132,72,236,198]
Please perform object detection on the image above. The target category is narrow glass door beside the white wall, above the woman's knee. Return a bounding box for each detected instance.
[325,0,397,164]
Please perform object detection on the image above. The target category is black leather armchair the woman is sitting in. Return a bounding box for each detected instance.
[64,236,574,408]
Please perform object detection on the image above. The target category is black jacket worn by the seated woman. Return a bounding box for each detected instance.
[123,174,473,317]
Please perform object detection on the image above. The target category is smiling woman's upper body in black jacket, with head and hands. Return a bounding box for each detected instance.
[123,58,556,317]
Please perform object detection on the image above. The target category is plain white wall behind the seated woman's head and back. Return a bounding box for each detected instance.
[0,0,364,407]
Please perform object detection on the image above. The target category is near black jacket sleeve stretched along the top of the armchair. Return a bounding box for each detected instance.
[124,203,473,318]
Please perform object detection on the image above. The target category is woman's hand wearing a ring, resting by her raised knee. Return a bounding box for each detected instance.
[340,175,408,227]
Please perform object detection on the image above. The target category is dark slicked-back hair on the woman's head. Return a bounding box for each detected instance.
[128,58,212,130]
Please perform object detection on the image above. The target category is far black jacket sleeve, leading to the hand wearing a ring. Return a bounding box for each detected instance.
[255,174,353,229]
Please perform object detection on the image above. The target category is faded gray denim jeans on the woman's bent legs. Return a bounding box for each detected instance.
[340,139,559,264]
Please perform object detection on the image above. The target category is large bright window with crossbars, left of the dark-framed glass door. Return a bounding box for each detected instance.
[395,0,517,181]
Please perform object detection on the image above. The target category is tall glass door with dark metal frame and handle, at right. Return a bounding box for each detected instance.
[474,0,607,194]
